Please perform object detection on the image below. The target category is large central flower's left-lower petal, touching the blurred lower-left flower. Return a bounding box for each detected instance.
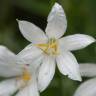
[17,44,43,67]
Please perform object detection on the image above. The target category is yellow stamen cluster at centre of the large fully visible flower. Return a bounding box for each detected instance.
[37,38,59,55]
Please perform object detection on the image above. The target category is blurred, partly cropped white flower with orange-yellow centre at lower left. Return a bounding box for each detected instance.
[0,46,39,96]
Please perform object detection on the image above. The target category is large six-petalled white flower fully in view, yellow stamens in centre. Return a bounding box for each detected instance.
[18,3,95,91]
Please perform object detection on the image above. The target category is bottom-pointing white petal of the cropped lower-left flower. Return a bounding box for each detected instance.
[16,77,39,96]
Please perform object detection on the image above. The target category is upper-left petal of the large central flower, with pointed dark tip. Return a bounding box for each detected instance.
[17,20,47,43]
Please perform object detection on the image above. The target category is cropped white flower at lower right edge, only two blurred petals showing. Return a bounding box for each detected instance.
[74,63,96,96]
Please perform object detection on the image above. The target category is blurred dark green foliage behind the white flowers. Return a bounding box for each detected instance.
[0,0,96,96]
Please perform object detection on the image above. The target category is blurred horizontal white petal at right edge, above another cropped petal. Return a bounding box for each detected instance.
[80,63,96,77]
